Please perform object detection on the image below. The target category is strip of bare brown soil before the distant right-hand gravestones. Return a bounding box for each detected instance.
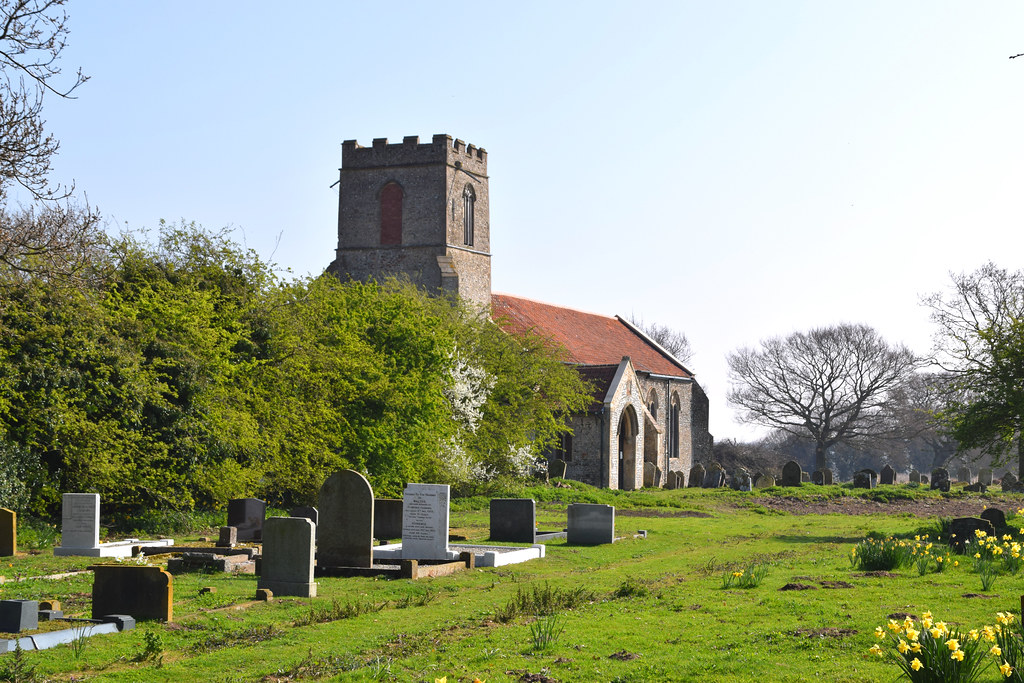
[749,496,995,519]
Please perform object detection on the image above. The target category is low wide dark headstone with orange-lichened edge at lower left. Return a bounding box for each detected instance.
[89,564,174,622]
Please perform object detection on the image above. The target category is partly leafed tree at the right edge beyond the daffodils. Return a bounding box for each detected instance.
[925,262,1024,477]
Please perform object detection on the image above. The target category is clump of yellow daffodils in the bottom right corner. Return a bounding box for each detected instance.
[868,611,1021,683]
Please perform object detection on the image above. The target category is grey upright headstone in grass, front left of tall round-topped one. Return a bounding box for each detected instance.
[256,517,316,598]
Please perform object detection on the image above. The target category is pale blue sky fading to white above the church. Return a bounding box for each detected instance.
[19,0,1024,440]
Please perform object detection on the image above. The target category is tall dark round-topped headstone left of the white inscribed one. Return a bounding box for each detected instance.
[316,470,374,567]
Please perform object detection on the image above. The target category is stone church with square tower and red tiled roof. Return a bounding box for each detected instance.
[328,135,713,489]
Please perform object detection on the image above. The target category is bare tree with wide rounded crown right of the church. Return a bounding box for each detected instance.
[728,324,918,469]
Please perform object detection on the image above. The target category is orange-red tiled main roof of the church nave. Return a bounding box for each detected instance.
[490,294,693,377]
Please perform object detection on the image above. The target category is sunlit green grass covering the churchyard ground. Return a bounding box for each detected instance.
[0,486,1024,682]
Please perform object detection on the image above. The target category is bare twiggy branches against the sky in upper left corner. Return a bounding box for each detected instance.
[0,0,88,202]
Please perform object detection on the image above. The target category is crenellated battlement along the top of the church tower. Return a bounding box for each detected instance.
[341,134,487,175]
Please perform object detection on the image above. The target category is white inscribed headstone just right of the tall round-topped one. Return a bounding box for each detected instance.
[401,483,451,560]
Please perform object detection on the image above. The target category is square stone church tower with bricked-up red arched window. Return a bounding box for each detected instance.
[328,135,490,306]
